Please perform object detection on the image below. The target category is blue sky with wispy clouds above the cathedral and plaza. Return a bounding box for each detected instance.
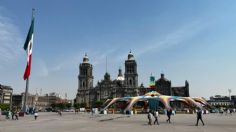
[0,0,236,98]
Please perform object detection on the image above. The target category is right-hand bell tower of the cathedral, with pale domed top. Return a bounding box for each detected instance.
[125,51,138,88]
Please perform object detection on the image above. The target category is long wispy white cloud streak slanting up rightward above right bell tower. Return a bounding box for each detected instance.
[109,20,207,62]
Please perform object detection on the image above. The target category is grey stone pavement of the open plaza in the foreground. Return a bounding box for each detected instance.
[0,112,236,132]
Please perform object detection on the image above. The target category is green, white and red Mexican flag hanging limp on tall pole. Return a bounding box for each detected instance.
[24,18,34,80]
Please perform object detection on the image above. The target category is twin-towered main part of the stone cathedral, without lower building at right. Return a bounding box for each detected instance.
[76,52,145,107]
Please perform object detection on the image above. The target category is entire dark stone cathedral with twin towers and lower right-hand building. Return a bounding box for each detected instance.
[76,51,189,107]
